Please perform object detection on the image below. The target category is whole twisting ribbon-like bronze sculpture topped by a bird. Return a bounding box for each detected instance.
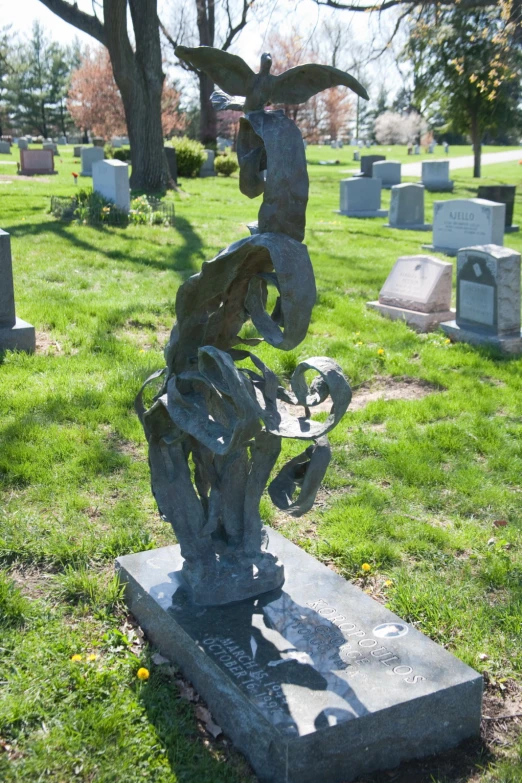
[136,47,365,605]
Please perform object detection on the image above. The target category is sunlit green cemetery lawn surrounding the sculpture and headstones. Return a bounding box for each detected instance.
[0,142,522,783]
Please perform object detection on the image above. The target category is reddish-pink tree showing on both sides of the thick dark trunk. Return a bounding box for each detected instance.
[67,47,185,139]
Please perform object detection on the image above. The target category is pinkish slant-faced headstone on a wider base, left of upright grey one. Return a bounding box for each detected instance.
[367,256,455,332]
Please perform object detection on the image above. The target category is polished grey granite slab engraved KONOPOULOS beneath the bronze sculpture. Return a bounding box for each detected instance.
[116,530,482,783]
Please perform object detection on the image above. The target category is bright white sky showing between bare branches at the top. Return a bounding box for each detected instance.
[0,0,399,97]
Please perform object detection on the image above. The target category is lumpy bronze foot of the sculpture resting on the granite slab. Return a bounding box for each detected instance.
[181,552,285,606]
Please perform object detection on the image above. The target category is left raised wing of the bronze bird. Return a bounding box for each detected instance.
[175,46,255,95]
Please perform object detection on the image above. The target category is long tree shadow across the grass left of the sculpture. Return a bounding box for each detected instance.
[3,216,205,272]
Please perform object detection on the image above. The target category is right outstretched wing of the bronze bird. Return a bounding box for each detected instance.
[270,63,368,103]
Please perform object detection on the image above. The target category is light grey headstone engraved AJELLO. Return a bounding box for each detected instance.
[422,198,506,256]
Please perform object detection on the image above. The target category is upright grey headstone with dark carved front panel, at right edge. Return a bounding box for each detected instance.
[441,245,522,354]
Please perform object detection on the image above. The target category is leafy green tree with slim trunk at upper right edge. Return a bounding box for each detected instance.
[406,5,522,177]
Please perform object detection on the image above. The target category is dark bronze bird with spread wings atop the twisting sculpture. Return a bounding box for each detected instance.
[176,46,368,114]
